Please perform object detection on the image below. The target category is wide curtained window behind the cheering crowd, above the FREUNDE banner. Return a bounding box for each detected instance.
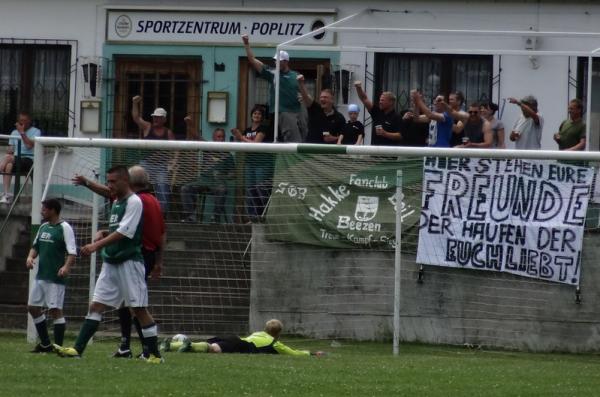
[373,54,492,110]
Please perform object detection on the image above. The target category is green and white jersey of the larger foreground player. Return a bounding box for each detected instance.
[102,194,144,265]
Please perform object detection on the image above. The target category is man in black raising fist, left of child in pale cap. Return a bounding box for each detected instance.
[298,74,346,143]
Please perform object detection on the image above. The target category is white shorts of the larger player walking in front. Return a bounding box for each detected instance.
[92,260,148,308]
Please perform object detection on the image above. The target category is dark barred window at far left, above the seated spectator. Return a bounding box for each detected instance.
[0,44,71,136]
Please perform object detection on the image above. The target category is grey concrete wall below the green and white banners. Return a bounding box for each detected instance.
[250,225,600,352]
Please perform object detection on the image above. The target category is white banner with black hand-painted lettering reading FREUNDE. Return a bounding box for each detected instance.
[417,157,593,285]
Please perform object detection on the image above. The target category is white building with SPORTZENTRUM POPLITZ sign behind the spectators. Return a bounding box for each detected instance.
[0,0,600,150]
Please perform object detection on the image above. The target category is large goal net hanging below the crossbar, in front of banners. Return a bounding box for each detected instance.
[27,138,598,349]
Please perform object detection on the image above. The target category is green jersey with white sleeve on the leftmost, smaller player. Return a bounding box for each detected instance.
[33,221,77,284]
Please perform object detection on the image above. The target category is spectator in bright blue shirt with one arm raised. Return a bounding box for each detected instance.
[410,90,453,147]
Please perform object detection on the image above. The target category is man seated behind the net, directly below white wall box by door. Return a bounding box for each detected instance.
[181,128,235,223]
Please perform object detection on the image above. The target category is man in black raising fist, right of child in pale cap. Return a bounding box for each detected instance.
[354,81,403,146]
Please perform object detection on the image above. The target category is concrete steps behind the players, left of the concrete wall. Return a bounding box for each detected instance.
[0,220,252,335]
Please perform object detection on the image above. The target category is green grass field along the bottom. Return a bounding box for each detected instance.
[0,333,600,397]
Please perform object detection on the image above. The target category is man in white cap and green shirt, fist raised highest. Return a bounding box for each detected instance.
[242,35,302,142]
